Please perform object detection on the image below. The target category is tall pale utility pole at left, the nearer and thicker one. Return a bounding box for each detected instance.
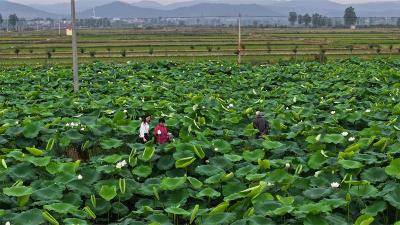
[71,0,79,93]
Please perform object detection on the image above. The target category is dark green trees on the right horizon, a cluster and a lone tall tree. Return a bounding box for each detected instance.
[289,7,357,27]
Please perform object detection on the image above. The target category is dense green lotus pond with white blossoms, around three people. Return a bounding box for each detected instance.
[0,59,400,225]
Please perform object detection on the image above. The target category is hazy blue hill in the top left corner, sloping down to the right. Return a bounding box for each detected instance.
[0,0,57,19]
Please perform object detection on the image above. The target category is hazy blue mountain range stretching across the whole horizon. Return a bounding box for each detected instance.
[0,0,400,19]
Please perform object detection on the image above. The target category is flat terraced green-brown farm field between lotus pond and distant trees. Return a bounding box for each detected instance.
[0,27,400,65]
